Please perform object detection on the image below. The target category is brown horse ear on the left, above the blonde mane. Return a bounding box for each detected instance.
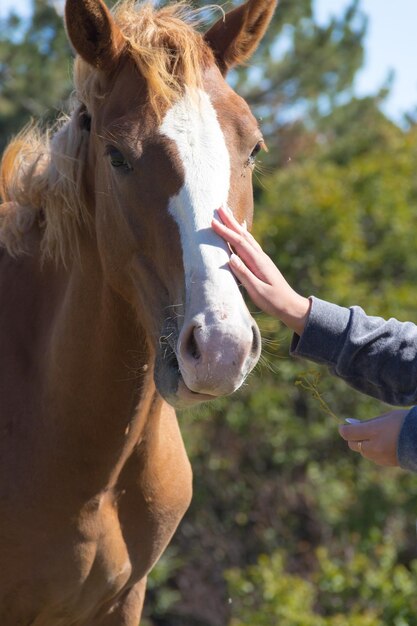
[65,0,126,70]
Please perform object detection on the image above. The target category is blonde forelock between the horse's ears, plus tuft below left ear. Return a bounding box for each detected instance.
[75,0,214,119]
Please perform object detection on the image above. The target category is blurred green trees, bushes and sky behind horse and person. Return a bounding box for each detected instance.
[0,0,417,626]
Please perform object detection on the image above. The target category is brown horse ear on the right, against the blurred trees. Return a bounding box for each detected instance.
[205,0,277,75]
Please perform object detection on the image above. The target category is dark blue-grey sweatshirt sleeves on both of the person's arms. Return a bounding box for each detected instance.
[291,297,417,472]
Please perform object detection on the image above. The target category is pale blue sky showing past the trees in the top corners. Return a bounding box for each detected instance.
[0,0,417,120]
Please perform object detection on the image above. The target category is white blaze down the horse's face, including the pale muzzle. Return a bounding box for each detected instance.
[160,90,256,395]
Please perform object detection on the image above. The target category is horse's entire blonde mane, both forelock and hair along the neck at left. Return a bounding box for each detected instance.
[0,0,213,264]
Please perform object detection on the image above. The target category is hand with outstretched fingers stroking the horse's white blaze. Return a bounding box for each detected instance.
[212,207,310,335]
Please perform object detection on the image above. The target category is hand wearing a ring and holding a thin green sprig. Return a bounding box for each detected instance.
[339,409,409,466]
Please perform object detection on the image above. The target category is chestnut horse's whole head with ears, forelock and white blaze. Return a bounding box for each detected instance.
[66,0,275,406]
